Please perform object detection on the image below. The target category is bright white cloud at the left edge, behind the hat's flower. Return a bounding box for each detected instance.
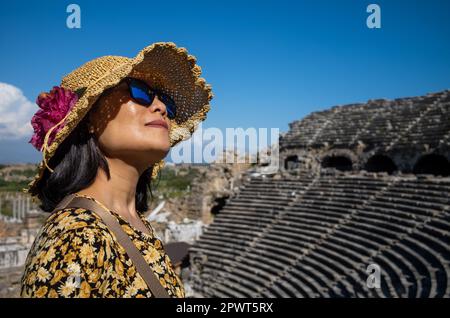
[0,83,37,140]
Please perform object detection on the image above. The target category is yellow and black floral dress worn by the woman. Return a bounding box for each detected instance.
[21,195,184,298]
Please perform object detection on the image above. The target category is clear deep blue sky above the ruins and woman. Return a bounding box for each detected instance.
[0,0,450,162]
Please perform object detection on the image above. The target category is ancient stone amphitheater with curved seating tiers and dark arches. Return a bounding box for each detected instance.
[190,90,450,298]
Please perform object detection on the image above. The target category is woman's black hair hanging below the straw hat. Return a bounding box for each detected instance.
[31,116,153,213]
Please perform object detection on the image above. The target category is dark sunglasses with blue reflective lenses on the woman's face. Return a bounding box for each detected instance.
[124,77,176,119]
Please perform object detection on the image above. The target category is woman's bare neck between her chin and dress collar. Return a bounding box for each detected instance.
[78,158,143,219]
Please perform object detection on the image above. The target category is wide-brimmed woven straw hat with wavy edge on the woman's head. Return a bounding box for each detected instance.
[24,42,213,193]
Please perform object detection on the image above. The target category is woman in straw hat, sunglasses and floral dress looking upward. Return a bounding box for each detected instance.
[21,43,212,297]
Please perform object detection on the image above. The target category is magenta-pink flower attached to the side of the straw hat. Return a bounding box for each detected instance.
[29,86,78,151]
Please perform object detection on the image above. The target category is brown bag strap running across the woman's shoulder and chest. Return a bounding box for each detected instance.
[54,194,169,298]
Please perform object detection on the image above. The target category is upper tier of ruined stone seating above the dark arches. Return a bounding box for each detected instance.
[280,91,450,173]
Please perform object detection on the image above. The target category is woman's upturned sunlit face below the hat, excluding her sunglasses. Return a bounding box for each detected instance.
[89,82,170,168]
